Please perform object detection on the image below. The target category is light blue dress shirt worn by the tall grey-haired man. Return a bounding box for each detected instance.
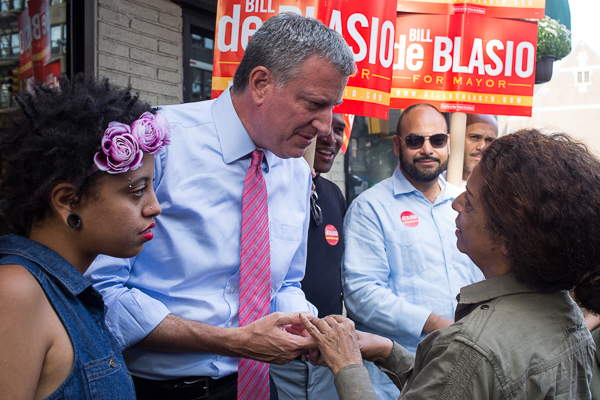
[86,90,316,379]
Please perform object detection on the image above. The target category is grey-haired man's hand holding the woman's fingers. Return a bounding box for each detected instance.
[234,311,317,364]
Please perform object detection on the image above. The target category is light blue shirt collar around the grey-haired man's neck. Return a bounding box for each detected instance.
[211,88,278,172]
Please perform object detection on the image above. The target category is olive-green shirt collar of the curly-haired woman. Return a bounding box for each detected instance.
[458,272,540,304]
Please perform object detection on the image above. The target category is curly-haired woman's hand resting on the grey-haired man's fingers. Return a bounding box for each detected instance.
[300,314,362,375]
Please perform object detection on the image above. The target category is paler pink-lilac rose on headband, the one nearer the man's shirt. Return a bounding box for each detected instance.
[131,112,171,154]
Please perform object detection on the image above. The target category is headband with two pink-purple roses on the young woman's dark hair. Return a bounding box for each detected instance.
[87,112,171,176]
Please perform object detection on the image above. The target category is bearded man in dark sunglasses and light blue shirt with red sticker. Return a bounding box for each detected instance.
[342,104,484,400]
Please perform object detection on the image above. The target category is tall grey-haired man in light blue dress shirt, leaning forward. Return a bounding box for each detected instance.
[86,14,355,399]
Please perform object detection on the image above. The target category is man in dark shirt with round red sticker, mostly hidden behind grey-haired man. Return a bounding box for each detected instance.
[270,114,346,400]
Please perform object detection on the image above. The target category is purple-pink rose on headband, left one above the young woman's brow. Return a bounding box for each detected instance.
[94,121,144,174]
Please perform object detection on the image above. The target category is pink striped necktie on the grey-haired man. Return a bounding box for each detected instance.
[237,149,271,400]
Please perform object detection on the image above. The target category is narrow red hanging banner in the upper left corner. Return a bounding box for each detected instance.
[27,0,51,82]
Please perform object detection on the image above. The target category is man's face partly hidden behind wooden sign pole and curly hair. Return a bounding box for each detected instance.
[463,114,498,182]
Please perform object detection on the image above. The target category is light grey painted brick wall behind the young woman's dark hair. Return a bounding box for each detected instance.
[96,0,183,105]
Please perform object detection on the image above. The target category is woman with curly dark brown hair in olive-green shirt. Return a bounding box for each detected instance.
[303,130,600,400]
